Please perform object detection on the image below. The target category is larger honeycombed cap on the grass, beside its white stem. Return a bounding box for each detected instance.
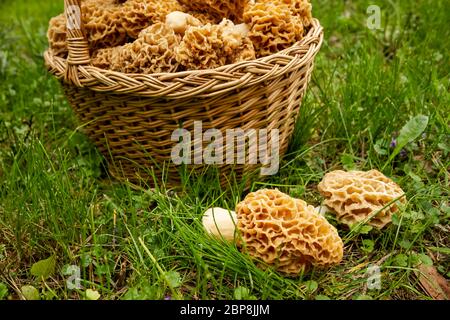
[236,189,343,276]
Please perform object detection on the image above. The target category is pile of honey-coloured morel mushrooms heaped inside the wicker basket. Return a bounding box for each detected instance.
[47,0,313,74]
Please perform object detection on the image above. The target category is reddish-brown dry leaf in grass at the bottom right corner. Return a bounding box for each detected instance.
[416,263,450,300]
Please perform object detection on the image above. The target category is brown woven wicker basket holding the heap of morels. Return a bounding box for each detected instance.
[45,0,323,186]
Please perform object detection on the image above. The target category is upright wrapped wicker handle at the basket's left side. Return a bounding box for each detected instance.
[64,0,91,87]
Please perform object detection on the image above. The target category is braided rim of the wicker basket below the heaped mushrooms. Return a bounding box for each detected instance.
[44,18,323,99]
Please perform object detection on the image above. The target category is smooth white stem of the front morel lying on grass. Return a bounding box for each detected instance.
[202,208,237,242]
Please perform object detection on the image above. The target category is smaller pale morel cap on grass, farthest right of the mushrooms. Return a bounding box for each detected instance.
[318,170,406,229]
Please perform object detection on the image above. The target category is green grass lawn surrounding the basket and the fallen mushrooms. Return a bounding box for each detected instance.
[0,0,450,299]
